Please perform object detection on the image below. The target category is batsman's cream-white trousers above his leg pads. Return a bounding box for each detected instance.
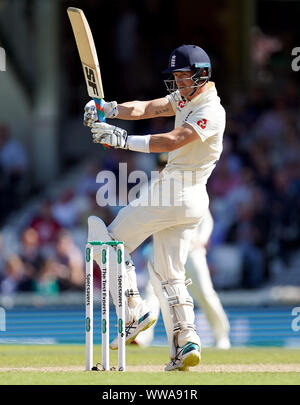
[108,171,209,346]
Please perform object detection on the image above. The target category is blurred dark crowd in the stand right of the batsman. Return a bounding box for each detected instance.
[208,83,300,288]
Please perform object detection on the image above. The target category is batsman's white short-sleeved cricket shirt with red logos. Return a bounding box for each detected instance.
[165,82,226,183]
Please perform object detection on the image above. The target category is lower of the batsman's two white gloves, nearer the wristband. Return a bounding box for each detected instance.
[91,122,128,149]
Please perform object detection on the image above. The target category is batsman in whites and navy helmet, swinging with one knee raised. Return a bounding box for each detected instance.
[84,45,225,371]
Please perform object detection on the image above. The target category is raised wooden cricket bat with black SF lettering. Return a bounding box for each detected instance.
[67,7,105,122]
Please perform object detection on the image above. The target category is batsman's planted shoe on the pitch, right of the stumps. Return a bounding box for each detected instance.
[165,342,201,371]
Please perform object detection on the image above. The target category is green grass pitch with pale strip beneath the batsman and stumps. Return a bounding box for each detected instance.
[0,345,300,385]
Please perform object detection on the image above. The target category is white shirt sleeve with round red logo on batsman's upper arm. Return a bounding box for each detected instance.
[185,109,225,142]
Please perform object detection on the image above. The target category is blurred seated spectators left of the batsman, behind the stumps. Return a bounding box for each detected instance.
[0,153,115,296]
